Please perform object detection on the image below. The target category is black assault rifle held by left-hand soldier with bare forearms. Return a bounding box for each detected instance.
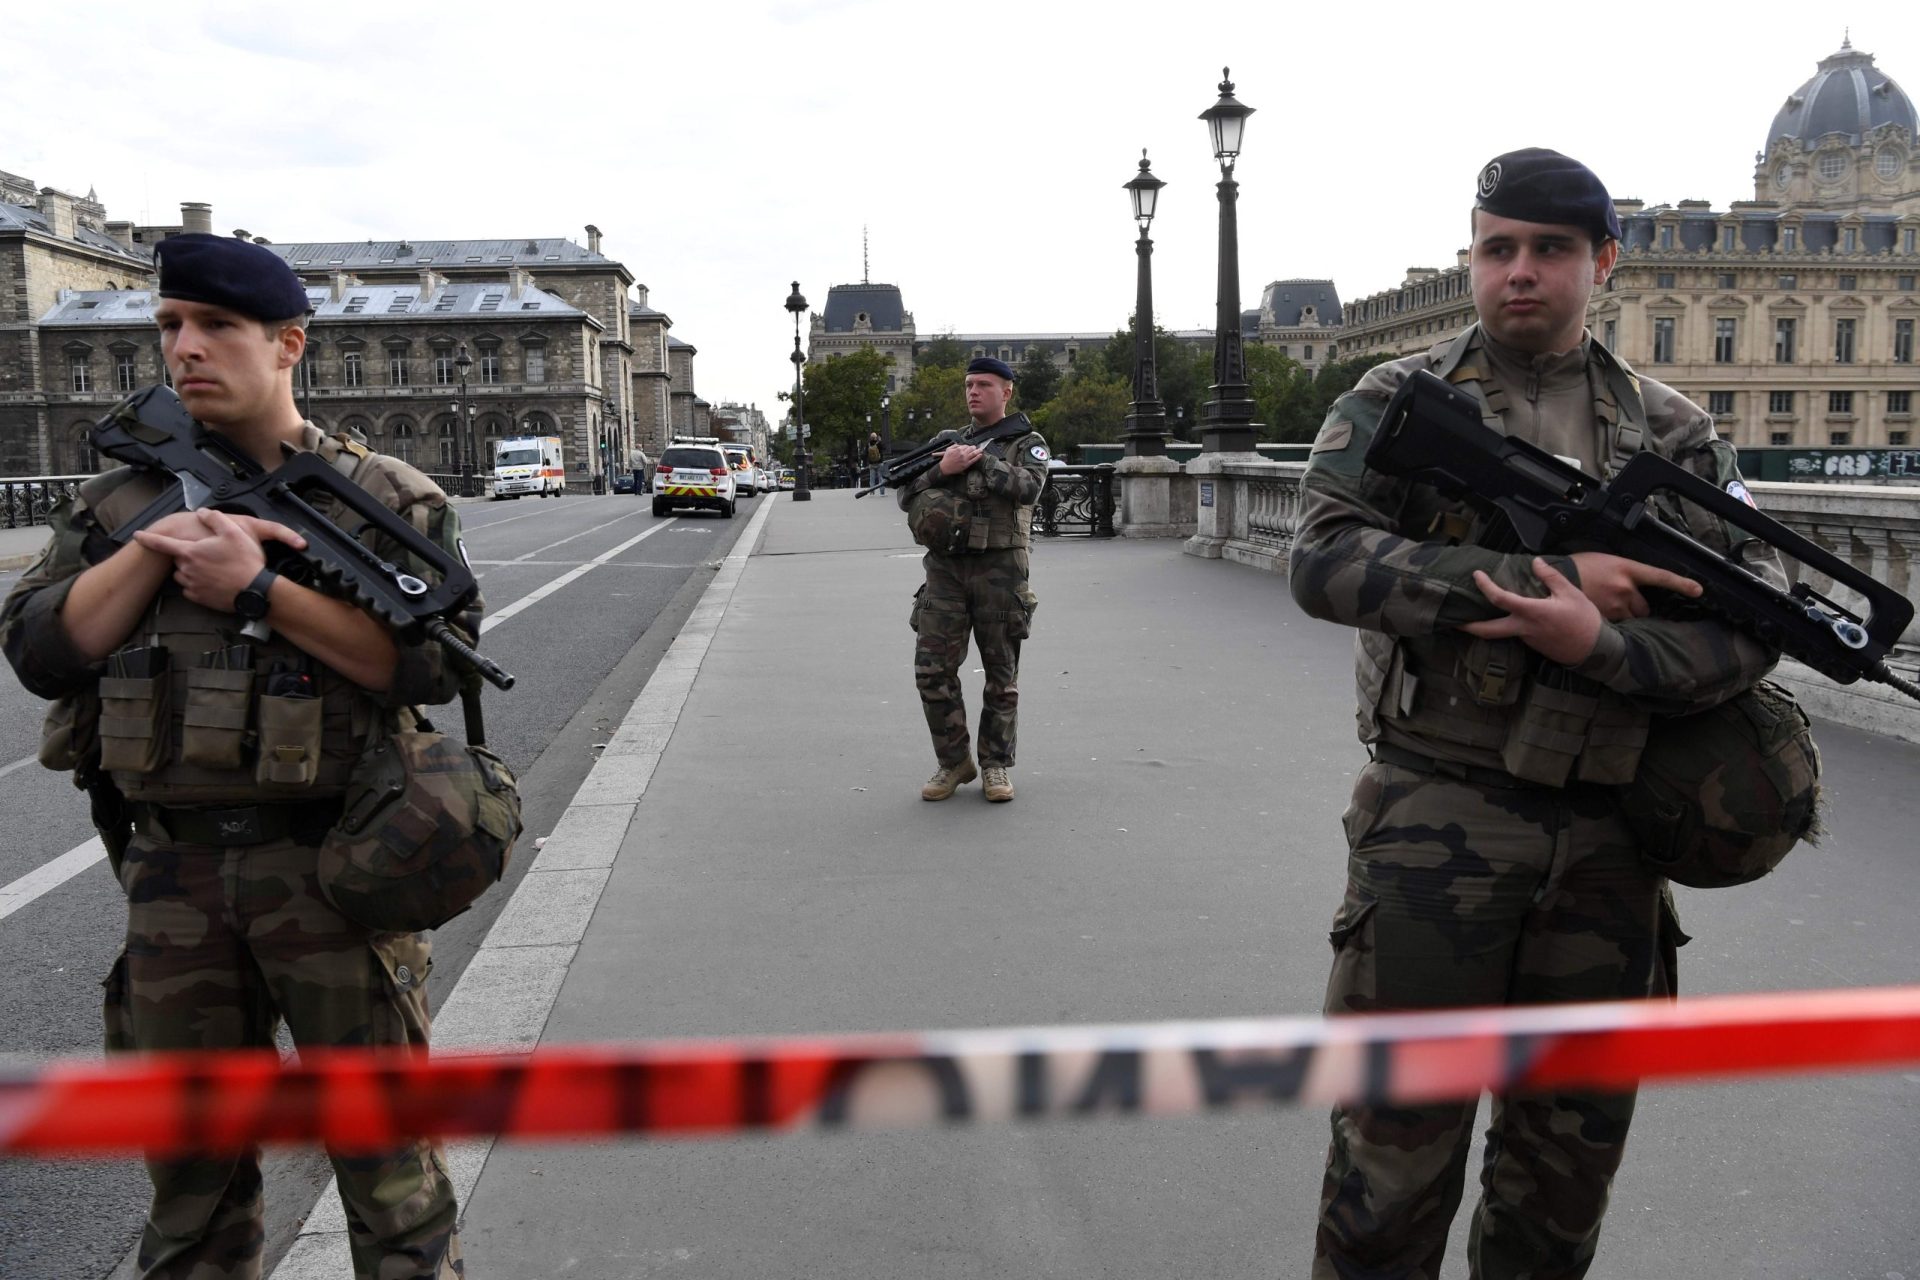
[92,386,513,690]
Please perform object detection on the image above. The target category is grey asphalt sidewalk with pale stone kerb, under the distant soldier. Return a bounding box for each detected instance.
[232,491,1920,1280]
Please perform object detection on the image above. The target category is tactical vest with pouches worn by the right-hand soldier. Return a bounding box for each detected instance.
[1357,324,1649,787]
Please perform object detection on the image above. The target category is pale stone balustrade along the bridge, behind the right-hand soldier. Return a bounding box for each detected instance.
[1116,453,1920,743]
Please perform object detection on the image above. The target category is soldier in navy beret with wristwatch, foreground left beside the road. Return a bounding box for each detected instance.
[0,236,480,1280]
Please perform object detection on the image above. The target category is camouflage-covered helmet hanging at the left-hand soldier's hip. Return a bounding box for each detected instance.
[319,720,520,933]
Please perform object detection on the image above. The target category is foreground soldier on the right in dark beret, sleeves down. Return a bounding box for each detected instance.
[1290,150,1784,1280]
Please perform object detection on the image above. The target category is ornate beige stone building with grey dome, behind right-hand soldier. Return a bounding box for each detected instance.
[1344,44,1920,447]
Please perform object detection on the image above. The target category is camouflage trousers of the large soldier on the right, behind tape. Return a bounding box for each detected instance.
[1313,762,1686,1280]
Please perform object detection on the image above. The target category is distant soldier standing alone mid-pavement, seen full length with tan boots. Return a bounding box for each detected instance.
[897,357,1048,802]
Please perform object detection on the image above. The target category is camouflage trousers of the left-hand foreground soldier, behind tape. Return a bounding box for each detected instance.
[106,835,463,1280]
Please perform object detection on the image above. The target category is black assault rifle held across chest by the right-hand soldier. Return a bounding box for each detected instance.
[1367,370,1920,700]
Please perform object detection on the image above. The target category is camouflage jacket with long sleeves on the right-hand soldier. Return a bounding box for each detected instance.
[1290,330,1786,762]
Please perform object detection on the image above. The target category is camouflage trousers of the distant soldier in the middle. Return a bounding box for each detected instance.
[912,547,1037,768]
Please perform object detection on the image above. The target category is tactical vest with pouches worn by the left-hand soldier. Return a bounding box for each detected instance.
[81,426,438,808]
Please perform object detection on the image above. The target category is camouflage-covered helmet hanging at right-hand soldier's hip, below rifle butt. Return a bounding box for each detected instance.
[1620,679,1820,889]
